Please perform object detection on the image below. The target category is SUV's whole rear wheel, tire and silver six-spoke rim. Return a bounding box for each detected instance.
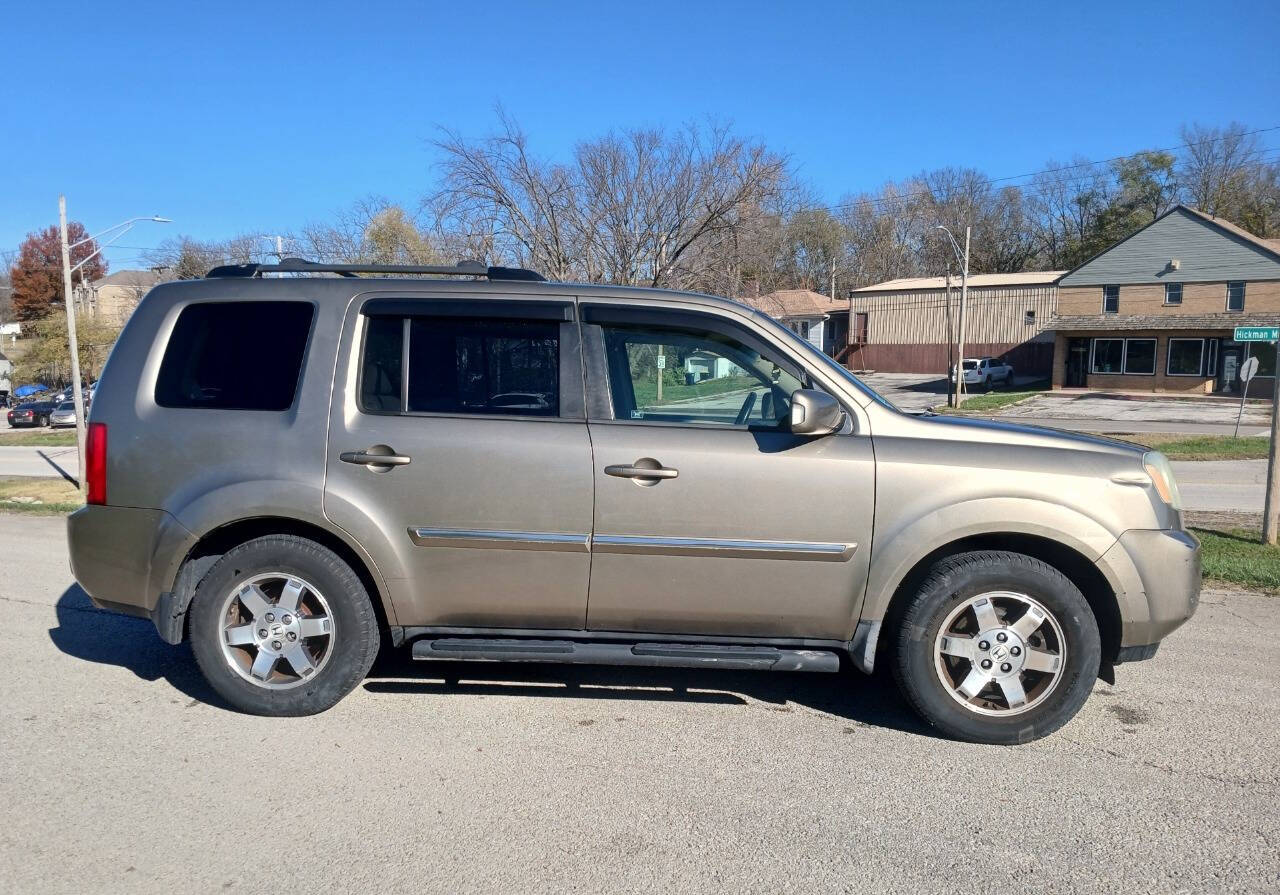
[189,535,379,716]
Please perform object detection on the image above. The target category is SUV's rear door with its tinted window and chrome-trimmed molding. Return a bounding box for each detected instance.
[325,296,593,629]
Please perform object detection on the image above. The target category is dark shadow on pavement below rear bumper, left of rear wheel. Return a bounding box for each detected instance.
[49,584,229,708]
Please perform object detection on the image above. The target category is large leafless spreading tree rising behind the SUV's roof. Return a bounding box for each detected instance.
[430,111,786,287]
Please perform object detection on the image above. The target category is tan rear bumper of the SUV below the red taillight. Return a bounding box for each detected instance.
[67,506,196,616]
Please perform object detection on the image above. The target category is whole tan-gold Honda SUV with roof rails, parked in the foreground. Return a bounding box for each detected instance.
[68,260,1199,743]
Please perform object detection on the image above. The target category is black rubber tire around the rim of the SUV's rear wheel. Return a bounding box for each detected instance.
[188,535,380,716]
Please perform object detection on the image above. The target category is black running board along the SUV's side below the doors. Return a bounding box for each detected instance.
[413,638,840,671]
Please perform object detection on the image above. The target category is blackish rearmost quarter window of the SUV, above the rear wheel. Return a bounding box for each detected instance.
[156,301,315,410]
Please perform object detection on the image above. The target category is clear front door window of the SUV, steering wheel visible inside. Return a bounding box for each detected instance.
[602,324,805,429]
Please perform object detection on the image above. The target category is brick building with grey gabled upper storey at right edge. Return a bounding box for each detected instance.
[1053,205,1280,397]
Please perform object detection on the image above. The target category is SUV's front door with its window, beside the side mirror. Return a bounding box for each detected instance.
[582,305,876,639]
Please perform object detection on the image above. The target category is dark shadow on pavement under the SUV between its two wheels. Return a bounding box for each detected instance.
[365,650,937,736]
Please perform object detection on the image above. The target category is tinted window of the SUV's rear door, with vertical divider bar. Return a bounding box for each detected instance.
[360,316,561,416]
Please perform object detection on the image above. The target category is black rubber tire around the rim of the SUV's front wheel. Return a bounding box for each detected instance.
[893,551,1102,745]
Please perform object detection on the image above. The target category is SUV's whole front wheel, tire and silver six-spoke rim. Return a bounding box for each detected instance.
[893,551,1102,744]
